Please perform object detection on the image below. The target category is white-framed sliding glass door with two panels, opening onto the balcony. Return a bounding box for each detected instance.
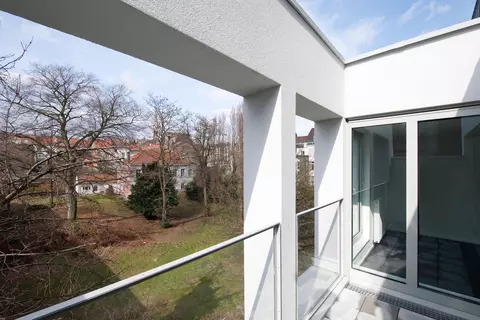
[346,107,480,306]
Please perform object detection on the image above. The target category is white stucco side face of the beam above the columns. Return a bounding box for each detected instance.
[123,0,344,113]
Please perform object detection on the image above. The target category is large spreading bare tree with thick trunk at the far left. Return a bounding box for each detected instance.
[0,64,141,220]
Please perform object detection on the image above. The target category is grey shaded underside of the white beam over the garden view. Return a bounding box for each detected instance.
[0,0,278,96]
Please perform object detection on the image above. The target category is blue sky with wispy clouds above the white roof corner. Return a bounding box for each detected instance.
[298,0,475,58]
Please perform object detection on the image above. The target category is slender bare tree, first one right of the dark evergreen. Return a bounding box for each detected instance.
[183,115,218,215]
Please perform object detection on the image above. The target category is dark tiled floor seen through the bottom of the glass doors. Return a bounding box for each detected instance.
[361,231,480,298]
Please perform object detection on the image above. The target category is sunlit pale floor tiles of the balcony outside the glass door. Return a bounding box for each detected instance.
[312,289,432,320]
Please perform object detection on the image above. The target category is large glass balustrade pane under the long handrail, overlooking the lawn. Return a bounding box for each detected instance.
[42,242,246,320]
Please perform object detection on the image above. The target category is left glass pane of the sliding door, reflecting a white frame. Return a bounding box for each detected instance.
[352,123,406,281]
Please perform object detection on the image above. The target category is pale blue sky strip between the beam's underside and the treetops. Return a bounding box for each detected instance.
[0,11,242,126]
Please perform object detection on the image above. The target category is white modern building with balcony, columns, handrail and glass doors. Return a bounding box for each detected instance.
[5,0,480,320]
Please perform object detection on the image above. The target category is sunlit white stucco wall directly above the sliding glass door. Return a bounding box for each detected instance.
[344,21,480,118]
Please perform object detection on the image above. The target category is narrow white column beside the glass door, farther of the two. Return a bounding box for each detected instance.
[314,118,344,272]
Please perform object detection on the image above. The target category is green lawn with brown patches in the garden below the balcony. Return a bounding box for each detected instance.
[8,195,243,320]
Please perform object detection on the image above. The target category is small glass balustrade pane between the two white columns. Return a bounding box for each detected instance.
[297,203,340,319]
